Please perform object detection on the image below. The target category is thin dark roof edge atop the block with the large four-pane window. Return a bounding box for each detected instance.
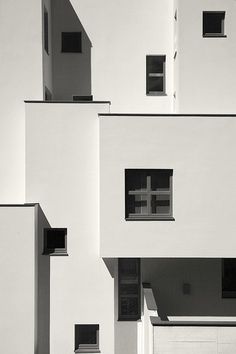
[98,113,236,117]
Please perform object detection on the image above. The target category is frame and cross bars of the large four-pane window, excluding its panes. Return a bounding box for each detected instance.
[125,168,175,221]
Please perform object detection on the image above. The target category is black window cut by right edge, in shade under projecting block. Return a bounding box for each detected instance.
[222,258,236,298]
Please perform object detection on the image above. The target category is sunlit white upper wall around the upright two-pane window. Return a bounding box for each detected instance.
[68,0,174,112]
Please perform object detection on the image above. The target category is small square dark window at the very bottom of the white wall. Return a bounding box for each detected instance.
[75,324,100,353]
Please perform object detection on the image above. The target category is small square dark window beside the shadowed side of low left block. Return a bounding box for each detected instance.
[43,228,67,255]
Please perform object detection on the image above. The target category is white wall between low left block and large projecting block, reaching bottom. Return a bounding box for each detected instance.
[26,103,114,354]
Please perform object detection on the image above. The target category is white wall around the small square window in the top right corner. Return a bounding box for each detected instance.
[176,0,236,113]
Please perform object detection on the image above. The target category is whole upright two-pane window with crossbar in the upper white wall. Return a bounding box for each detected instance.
[146,55,166,95]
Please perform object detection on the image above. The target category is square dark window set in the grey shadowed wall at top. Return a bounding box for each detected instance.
[61,32,82,53]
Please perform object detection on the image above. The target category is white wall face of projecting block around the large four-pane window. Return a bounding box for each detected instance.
[99,116,236,258]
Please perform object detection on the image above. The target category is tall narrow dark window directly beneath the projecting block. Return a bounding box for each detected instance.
[118,258,141,321]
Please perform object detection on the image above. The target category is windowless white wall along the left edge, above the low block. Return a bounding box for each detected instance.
[0,0,43,203]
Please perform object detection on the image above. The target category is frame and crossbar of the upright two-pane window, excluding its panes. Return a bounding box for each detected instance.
[146,54,166,96]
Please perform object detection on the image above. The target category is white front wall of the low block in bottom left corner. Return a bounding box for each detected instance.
[0,206,37,354]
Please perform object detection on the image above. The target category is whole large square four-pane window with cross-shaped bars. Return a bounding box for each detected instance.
[125,169,175,221]
